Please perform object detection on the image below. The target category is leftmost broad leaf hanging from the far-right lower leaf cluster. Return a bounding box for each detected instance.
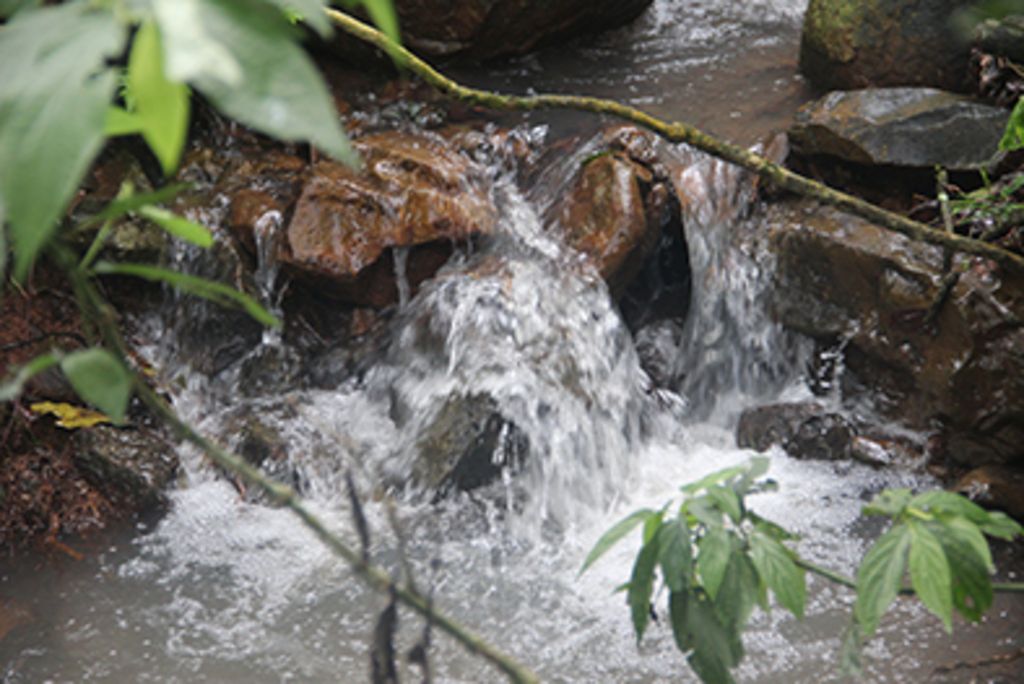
[854,524,910,637]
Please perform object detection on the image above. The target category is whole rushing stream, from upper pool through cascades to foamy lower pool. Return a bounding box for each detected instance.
[0,0,1024,684]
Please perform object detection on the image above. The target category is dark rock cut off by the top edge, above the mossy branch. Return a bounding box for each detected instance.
[336,0,651,60]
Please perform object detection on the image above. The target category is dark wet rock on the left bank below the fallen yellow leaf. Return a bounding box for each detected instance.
[75,425,178,510]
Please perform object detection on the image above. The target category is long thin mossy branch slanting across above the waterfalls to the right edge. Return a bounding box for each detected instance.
[325,9,1024,274]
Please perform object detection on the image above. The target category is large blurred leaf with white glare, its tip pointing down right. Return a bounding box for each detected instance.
[154,0,357,165]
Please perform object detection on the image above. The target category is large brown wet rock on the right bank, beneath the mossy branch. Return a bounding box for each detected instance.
[765,201,1024,466]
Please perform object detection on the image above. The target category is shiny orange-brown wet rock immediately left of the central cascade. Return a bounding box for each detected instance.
[283,132,495,307]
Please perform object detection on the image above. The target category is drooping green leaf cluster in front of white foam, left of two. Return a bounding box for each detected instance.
[581,457,807,682]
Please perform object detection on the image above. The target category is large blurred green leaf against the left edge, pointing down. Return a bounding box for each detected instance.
[0,2,126,281]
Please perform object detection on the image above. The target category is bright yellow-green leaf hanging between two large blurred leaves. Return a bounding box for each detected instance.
[122,20,189,177]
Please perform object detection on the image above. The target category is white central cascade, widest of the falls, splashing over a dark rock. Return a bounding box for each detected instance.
[367,183,648,518]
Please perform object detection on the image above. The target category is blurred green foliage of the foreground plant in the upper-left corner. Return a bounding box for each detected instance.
[0,0,397,423]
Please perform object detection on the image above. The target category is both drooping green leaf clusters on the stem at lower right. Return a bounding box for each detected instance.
[581,457,1022,684]
